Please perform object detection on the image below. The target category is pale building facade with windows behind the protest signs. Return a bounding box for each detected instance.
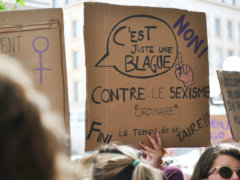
[10,0,240,154]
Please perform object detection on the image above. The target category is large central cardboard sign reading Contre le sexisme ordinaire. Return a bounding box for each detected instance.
[84,3,210,150]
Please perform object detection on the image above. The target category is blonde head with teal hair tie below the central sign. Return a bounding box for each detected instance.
[80,143,162,180]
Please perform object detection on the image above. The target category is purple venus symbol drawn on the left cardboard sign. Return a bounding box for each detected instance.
[32,36,52,84]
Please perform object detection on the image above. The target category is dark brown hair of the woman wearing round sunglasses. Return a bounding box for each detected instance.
[191,143,240,180]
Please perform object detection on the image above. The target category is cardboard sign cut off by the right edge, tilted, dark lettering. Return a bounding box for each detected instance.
[217,70,240,142]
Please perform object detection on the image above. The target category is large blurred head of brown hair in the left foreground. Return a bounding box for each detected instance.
[0,56,78,180]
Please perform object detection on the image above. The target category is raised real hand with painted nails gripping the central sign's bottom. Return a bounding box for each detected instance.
[140,131,166,168]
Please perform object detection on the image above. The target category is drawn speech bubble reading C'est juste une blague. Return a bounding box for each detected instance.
[95,14,178,78]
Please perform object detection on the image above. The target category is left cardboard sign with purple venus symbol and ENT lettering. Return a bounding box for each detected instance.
[0,9,70,134]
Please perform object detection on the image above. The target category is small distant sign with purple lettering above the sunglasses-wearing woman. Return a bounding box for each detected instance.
[210,115,232,144]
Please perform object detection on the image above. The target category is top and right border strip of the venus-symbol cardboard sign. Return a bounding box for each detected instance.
[0,8,71,145]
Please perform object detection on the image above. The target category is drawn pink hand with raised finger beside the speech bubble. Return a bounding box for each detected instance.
[175,52,194,87]
